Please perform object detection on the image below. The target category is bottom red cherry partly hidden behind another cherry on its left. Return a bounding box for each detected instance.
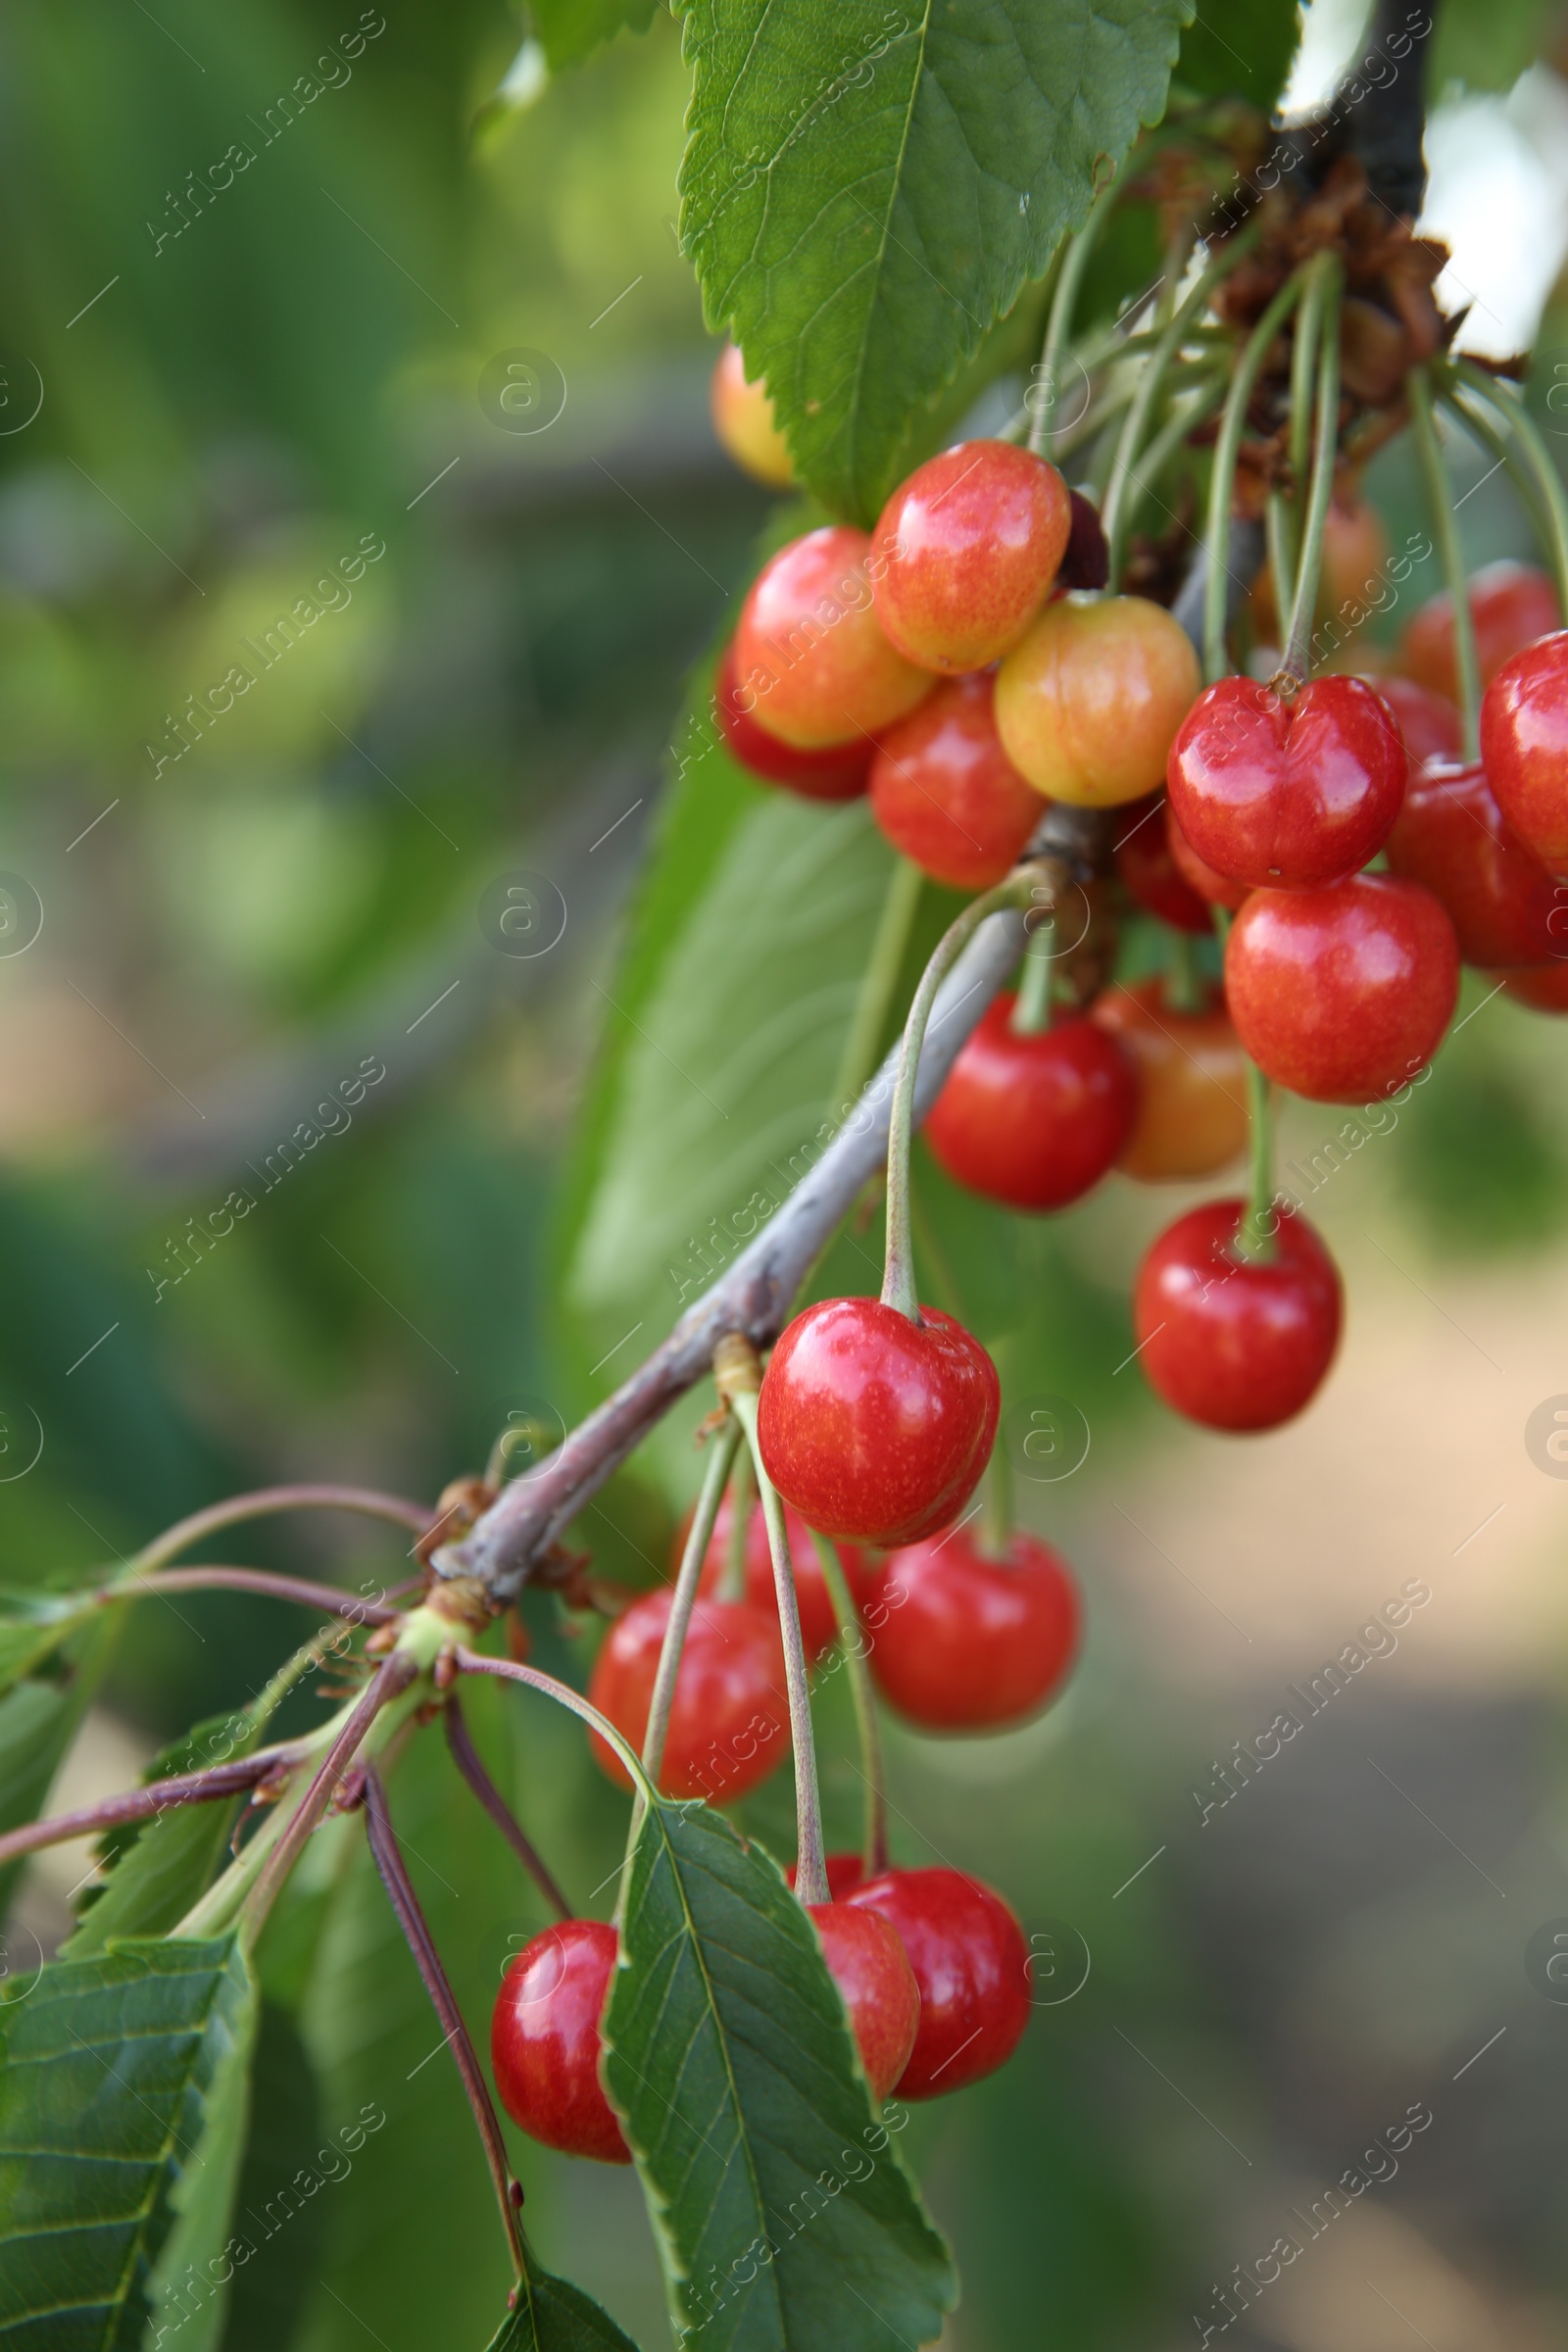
[849,1870,1030,2098]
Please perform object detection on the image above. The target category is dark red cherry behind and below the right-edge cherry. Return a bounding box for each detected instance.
[1387,760,1568,966]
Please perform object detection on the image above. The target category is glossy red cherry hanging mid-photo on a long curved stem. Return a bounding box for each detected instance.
[757,1298,1002,1547]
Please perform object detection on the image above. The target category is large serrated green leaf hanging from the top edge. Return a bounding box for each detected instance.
[679,0,1192,522]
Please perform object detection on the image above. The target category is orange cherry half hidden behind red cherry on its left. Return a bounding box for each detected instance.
[1091,978,1249,1183]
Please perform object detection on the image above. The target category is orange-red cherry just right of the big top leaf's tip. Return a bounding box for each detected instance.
[870,440,1072,672]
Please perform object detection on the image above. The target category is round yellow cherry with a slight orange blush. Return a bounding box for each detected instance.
[997,595,1199,809]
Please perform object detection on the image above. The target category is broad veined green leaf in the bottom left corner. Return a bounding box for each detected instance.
[0,1936,254,2352]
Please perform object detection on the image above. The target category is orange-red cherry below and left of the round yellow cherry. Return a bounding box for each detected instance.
[872,675,1044,889]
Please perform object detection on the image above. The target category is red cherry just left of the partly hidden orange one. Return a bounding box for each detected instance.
[926,990,1138,1209]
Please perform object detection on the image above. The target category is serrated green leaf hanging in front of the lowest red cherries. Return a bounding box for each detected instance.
[604,1801,956,2352]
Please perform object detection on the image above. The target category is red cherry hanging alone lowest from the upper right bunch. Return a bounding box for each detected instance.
[1133,1200,1343,1430]
